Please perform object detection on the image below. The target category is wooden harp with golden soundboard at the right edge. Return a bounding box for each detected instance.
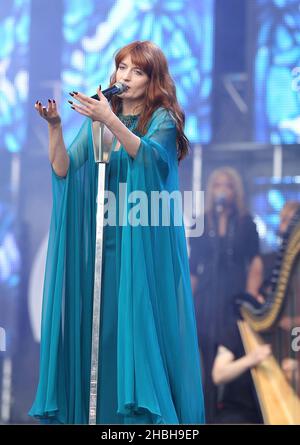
[238,210,300,425]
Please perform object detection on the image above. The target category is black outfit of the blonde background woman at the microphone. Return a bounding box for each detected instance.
[190,212,259,423]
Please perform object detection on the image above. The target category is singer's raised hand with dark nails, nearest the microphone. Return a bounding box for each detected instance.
[69,88,114,124]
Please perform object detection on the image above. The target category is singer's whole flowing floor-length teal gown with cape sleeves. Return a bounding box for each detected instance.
[30,108,204,424]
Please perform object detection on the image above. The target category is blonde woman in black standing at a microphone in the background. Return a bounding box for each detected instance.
[190,167,261,423]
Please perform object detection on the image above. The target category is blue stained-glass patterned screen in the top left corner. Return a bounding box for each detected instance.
[0,0,30,152]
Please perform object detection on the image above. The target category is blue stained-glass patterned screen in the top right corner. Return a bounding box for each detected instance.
[254,0,300,144]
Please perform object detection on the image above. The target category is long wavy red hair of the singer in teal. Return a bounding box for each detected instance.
[110,40,189,161]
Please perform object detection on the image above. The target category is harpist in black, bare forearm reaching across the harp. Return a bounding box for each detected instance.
[212,323,271,424]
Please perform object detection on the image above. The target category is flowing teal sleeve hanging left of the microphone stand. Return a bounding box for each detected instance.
[29,119,96,423]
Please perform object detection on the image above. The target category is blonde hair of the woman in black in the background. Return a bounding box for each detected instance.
[206,166,246,217]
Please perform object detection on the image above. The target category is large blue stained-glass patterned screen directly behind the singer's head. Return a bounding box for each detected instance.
[62,0,214,143]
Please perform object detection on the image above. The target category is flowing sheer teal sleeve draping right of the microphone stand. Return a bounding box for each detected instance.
[118,109,204,424]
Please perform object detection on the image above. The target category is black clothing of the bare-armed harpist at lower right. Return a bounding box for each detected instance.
[215,323,262,424]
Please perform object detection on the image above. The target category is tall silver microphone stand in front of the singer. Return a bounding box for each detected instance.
[89,122,112,425]
